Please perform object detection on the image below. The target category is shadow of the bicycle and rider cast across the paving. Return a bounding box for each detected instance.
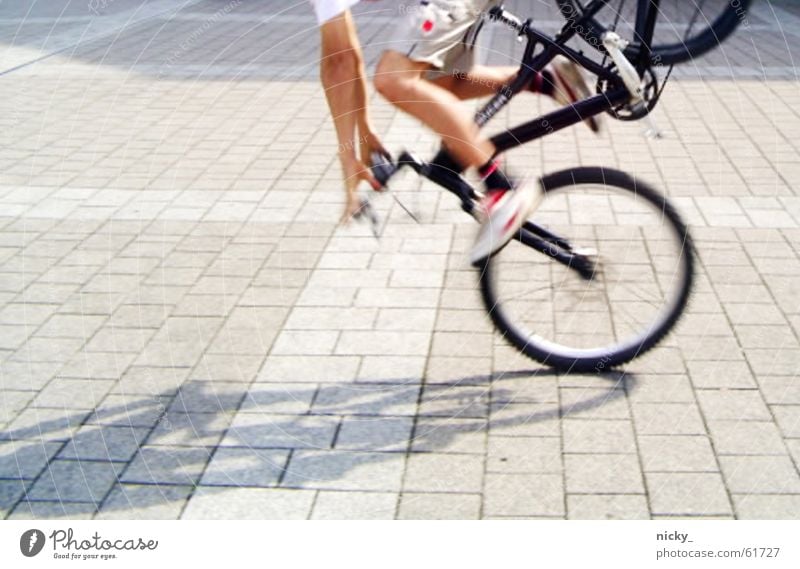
[0,370,637,519]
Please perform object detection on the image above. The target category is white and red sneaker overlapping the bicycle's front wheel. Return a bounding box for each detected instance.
[469,181,544,266]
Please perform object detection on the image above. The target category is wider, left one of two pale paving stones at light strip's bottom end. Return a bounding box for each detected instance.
[181,487,315,520]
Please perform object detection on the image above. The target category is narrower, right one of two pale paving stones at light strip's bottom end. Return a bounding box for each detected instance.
[311,490,398,520]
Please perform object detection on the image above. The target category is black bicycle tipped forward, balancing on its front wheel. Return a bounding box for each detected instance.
[365,0,749,372]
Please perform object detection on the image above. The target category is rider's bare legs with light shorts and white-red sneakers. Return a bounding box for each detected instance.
[374,0,598,264]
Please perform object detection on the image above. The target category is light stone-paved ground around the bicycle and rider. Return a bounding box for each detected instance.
[0,0,800,519]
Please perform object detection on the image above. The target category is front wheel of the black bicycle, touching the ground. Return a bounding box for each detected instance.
[480,168,694,372]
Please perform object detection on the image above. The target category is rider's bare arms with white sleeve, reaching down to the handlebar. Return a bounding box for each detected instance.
[311,0,388,223]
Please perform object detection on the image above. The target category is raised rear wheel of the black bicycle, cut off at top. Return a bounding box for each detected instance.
[557,0,751,65]
